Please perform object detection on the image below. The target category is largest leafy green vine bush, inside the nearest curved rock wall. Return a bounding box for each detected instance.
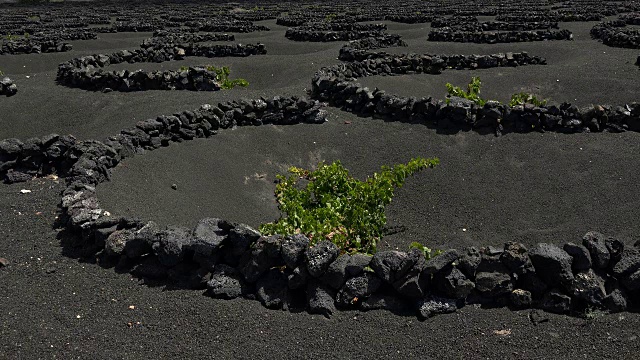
[260,157,439,254]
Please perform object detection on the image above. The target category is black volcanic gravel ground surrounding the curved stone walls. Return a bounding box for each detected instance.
[0,11,640,359]
